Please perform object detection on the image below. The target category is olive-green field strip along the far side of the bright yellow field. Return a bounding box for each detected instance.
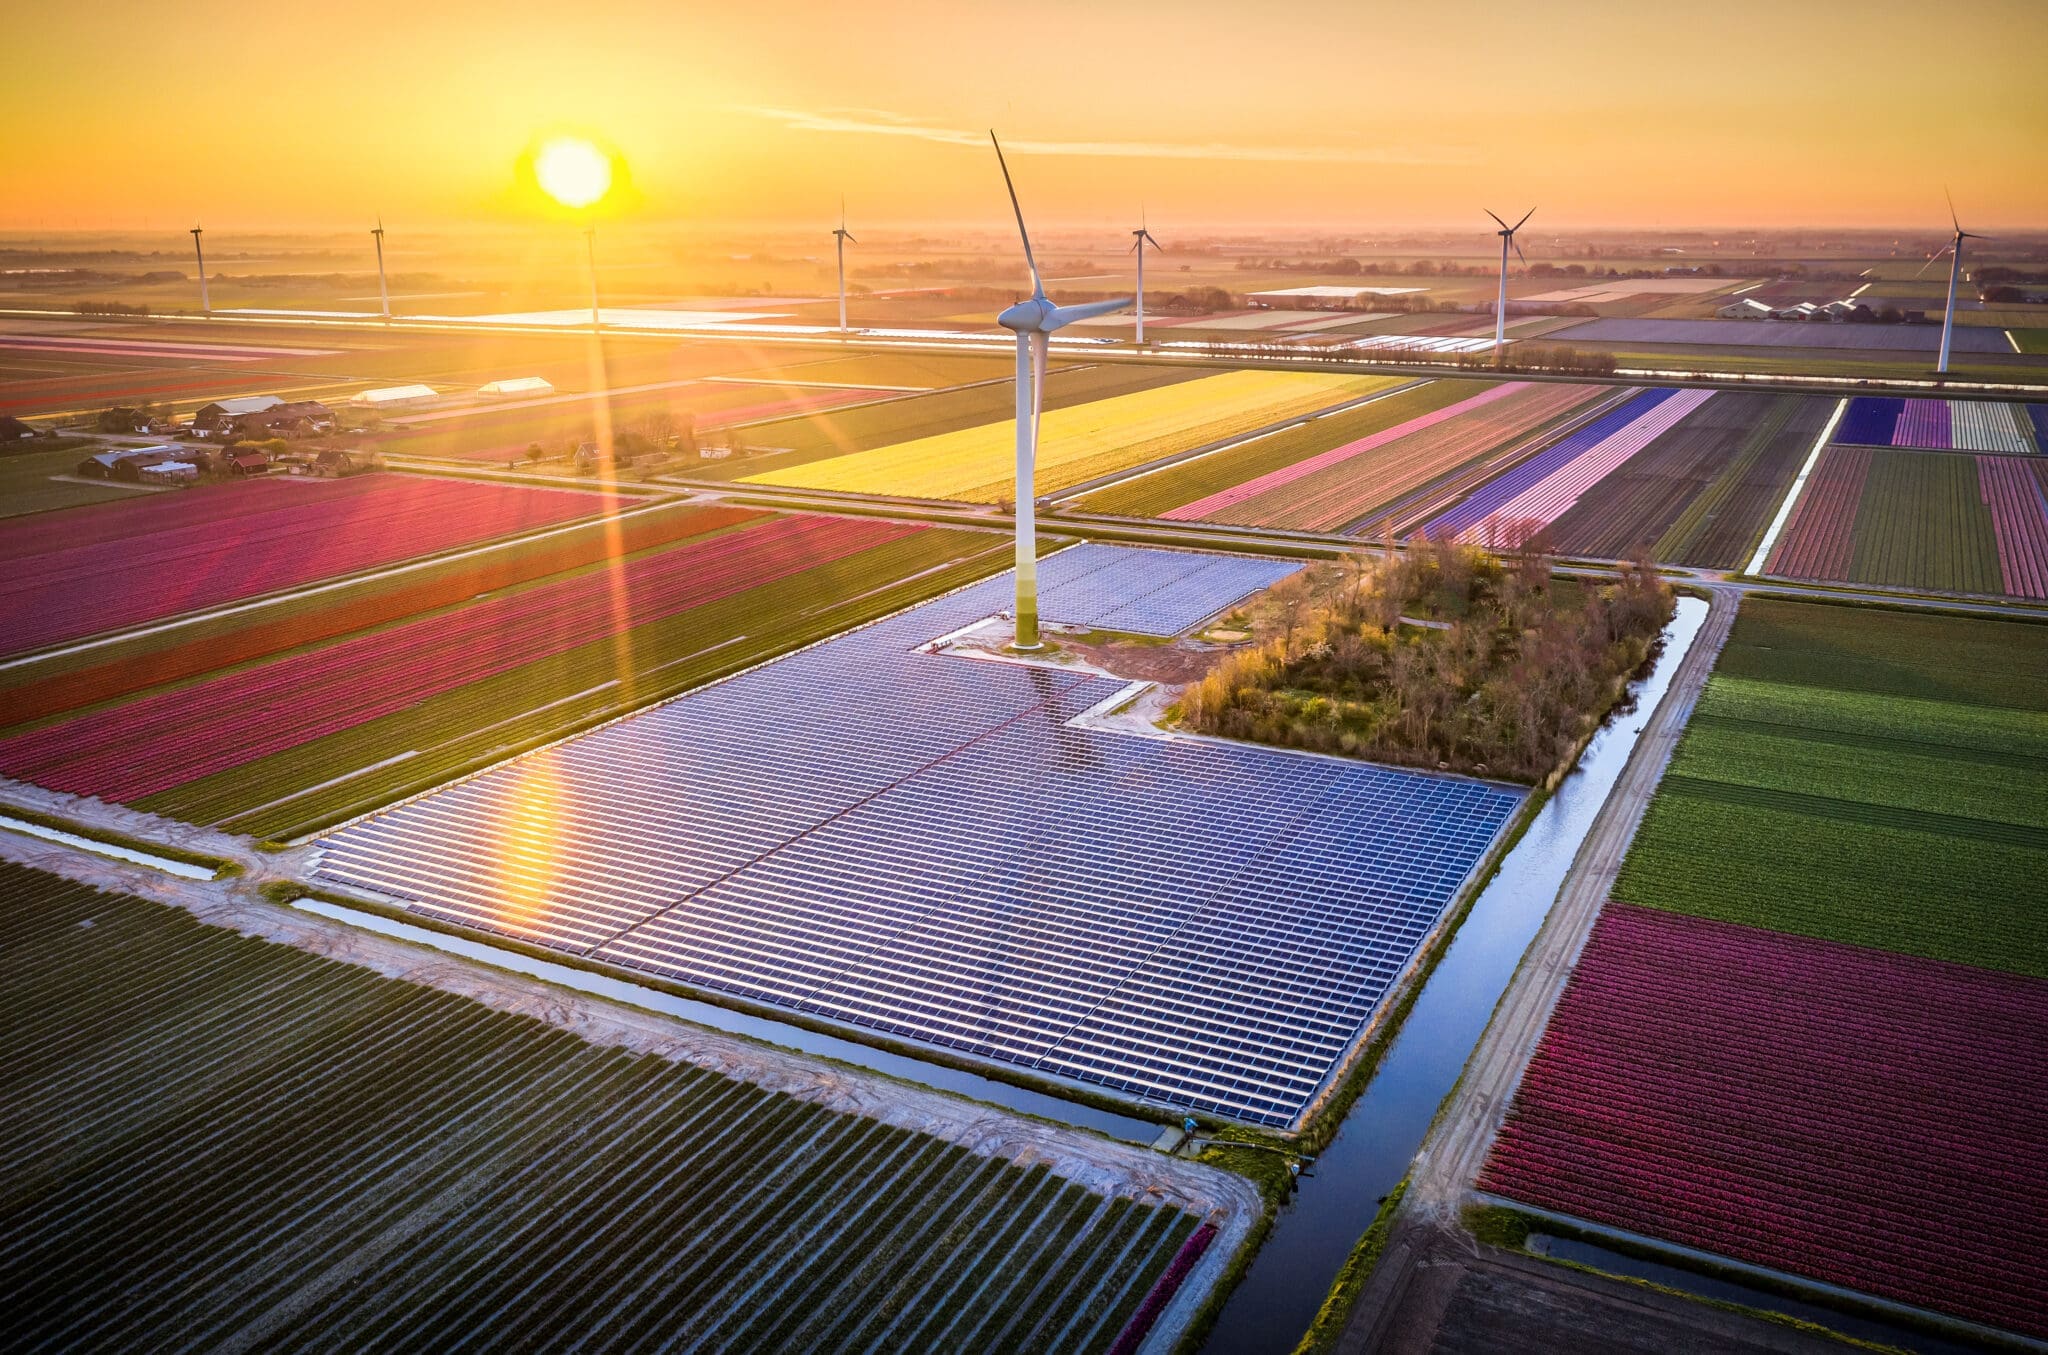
[694,362,1198,479]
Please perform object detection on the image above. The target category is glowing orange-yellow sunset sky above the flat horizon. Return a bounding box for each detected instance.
[0,0,2048,231]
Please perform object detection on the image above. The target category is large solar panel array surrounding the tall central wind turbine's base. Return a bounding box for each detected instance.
[317,547,1522,1124]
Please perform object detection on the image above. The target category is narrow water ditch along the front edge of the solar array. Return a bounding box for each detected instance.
[293,899,1161,1144]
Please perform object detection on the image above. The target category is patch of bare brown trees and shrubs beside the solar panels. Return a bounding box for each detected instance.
[1182,540,1673,782]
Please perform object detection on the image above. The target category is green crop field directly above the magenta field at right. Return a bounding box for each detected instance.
[1614,598,2048,976]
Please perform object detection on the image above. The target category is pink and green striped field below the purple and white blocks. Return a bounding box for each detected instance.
[1763,446,2048,598]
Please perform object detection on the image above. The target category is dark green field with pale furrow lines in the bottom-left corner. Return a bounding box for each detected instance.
[0,864,1196,1351]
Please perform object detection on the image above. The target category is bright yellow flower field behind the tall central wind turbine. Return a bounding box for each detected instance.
[745,370,1397,504]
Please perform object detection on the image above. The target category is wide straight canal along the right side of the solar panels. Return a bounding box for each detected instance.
[1202,598,1706,1355]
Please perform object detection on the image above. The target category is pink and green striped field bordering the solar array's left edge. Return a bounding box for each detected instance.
[0,510,1006,835]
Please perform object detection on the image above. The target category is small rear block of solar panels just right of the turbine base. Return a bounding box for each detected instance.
[1038,544,1300,635]
